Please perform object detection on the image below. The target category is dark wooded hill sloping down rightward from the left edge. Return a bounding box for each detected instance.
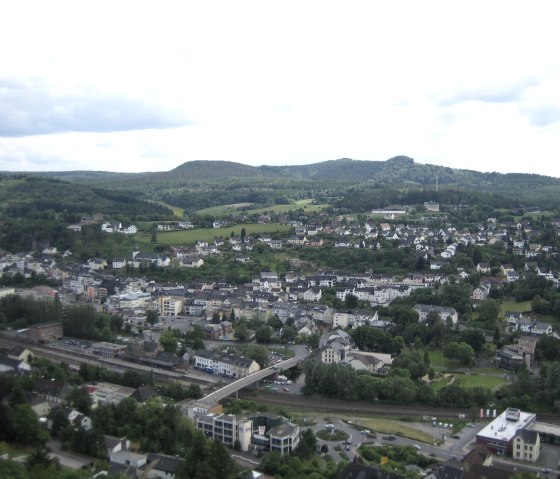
[0,174,173,222]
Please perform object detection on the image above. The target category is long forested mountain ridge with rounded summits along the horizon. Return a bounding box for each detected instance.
[13,156,560,212]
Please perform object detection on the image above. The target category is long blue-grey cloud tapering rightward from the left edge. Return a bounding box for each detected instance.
[0,79,190,137]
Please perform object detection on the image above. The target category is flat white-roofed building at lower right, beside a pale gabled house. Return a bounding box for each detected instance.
[476,408,537,456]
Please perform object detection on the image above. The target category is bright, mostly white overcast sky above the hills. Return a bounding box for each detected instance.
[0,0,560,178]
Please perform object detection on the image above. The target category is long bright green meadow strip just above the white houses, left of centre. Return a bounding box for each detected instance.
[134,223,292,247]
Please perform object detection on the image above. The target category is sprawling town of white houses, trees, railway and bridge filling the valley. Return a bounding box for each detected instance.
[0,201,560,479]
